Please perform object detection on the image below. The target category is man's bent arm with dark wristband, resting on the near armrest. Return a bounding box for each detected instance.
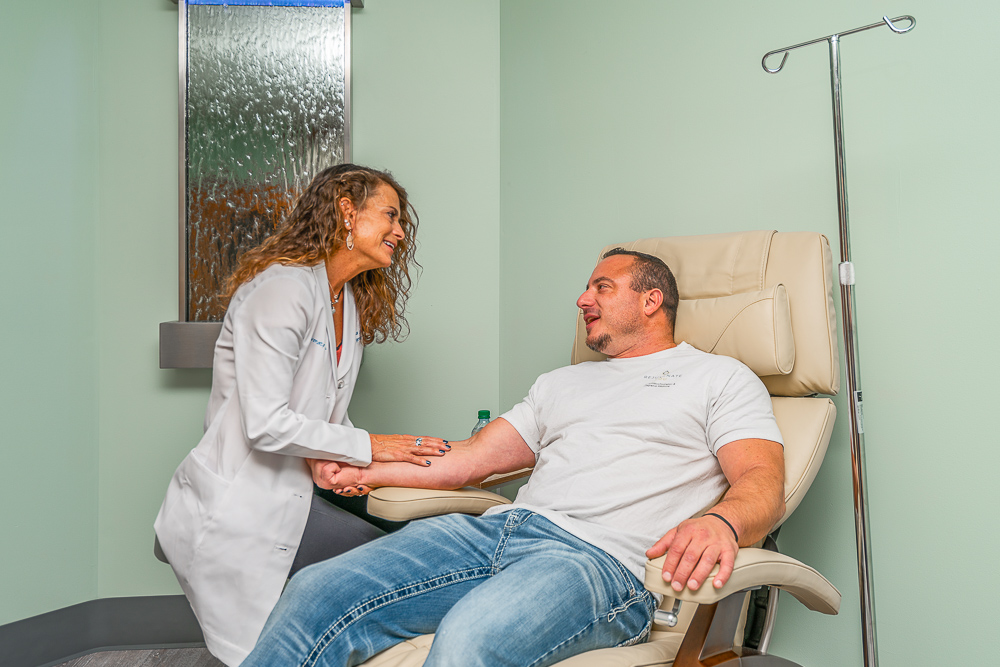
[644,440,785,591]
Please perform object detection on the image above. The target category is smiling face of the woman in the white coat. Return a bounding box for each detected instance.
[341,183,406,270]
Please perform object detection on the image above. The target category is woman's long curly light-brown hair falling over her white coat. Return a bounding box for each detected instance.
[225,164,420,345]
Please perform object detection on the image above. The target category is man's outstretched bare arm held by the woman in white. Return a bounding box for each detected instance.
[310,419,535,495]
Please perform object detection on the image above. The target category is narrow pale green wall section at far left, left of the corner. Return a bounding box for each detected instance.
[0,0,98,624]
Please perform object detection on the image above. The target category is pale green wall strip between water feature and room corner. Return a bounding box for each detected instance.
[351,0,501,439]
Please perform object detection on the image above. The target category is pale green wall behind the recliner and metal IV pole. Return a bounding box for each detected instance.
[500,0,1000,666]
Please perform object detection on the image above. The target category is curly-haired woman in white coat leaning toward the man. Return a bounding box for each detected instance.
[155,165,448,665]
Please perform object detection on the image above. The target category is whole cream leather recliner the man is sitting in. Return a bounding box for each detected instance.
[365,231,840,667]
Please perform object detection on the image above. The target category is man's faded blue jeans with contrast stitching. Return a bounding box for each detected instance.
[242,509,656,667]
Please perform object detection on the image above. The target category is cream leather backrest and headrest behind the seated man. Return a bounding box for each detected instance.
[571,231,840,524]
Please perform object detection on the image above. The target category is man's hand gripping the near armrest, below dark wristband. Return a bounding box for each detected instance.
[646,516,739,592]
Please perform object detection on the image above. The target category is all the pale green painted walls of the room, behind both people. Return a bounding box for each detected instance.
[0,0,1000,666]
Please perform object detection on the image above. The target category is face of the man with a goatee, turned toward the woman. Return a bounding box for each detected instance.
[576,255,643,357]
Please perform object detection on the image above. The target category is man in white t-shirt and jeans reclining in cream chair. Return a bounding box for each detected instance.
[244,249,784,667]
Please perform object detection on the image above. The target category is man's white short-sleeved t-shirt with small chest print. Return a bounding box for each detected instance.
[487,343,782,581]
